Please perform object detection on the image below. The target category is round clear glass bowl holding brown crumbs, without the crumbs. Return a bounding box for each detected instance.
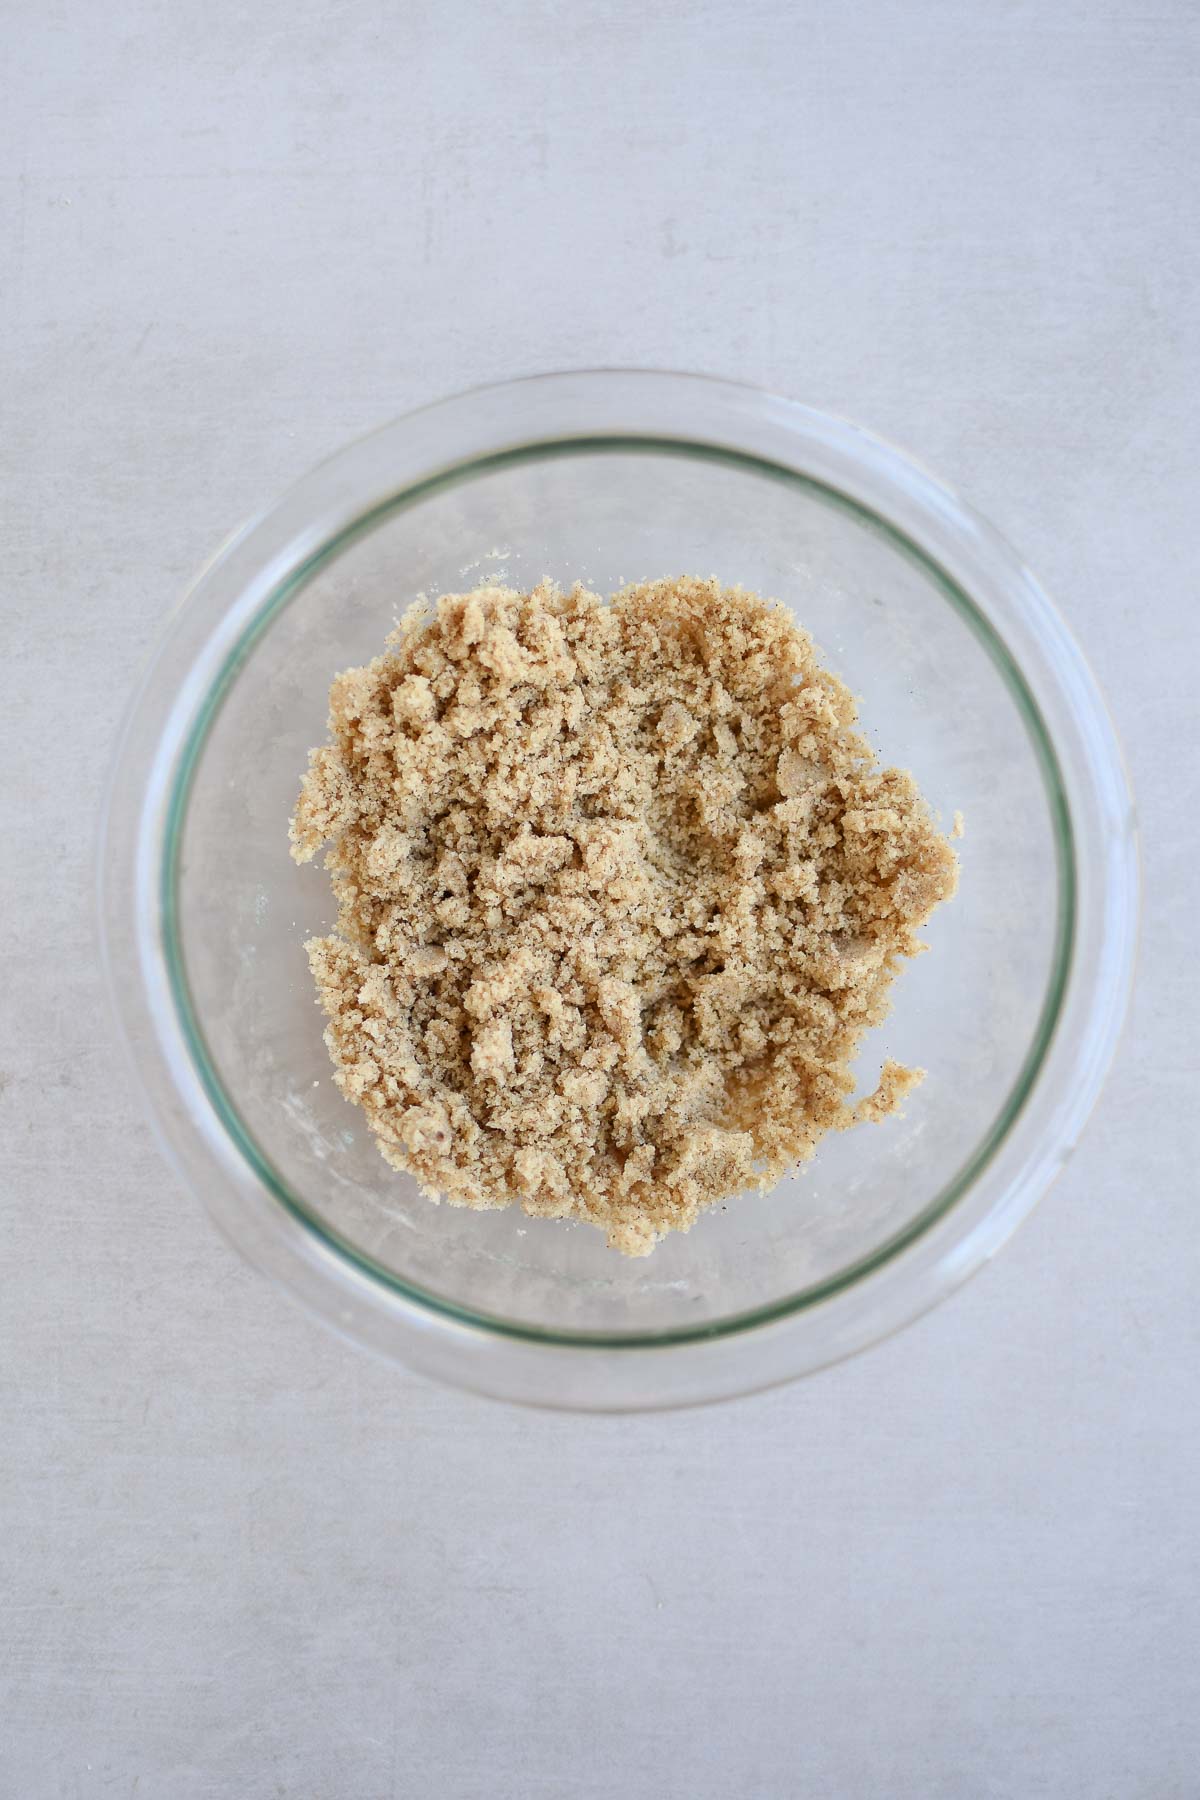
[103,371,1137,1408]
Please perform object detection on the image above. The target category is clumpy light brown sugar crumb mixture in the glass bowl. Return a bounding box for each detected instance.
[291,578,957,1256]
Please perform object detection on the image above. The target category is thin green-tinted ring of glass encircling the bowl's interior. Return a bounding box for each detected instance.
[160,434,1078,1350]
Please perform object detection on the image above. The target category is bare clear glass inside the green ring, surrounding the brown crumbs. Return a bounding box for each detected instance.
[167,443,1065,1337]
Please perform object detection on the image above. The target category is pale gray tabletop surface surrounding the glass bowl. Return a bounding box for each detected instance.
[0,0,1200,1800]
